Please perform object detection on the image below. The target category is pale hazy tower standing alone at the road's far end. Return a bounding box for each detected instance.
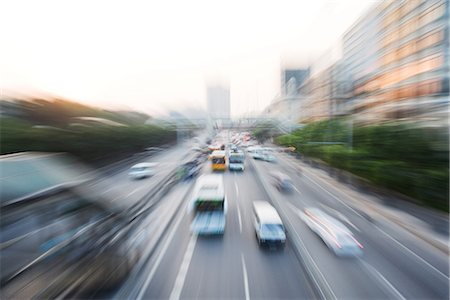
[206,85,231,119]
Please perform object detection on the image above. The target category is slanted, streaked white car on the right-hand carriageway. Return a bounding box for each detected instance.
[305,208,364,256]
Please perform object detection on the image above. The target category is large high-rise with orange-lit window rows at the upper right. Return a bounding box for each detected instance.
[343,0,449,122]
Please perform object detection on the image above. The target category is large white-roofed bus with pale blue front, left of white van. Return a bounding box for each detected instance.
[189,174,227,234]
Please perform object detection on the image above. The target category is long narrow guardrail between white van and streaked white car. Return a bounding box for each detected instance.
[249,158,337,299]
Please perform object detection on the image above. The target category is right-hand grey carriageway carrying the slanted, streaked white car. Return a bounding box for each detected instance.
[253,154,449,299]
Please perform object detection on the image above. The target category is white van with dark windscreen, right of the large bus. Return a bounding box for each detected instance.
[253,201,286,246]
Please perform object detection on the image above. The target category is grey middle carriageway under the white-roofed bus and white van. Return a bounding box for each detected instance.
[133,163,316,299]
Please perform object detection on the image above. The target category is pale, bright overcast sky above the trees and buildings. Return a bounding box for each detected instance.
[0,0,374,115]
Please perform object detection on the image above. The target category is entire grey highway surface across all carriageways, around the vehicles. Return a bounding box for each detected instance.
[3,134,449,299]
